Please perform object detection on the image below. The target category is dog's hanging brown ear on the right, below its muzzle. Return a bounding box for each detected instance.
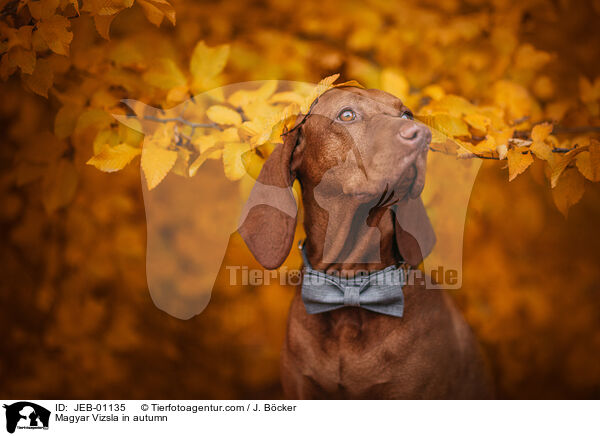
[394,197,435,267]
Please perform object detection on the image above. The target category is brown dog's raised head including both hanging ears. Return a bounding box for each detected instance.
[239,87,435,268]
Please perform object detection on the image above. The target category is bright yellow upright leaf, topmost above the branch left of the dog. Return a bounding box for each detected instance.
[190,41,229,92]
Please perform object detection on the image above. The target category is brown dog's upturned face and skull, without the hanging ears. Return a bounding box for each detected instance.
[290,88,431,202]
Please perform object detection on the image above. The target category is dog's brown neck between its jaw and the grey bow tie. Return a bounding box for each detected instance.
[303,187,399,277]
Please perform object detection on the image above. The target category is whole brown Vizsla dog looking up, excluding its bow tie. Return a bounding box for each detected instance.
[239,88,490,399]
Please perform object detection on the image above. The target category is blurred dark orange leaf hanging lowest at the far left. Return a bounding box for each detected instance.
[42,158,79,213]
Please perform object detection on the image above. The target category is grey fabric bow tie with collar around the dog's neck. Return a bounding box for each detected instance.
[299,243,406,317]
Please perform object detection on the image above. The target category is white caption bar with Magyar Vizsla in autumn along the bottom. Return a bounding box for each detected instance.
[0,400,600,436]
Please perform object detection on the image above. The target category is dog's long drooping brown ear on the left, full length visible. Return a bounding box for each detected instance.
[238,127,302,269]
